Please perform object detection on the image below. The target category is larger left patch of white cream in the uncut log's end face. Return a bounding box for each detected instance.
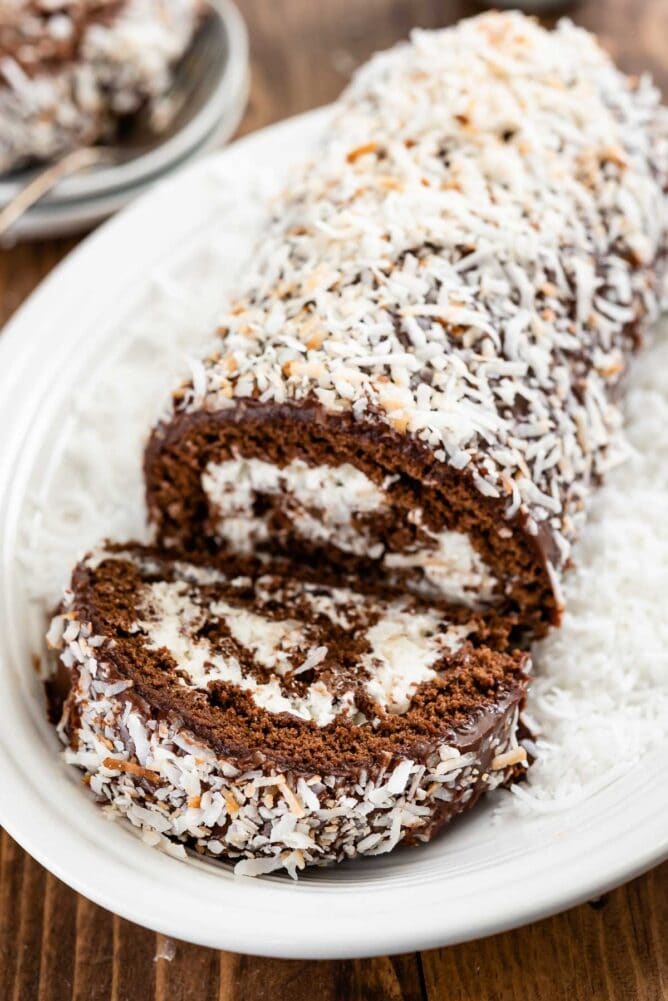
[202,457,393,559]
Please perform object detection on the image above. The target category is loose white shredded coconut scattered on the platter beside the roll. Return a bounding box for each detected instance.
[14,17,668,868]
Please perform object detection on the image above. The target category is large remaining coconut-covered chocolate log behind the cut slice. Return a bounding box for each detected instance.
[145,13,667,635]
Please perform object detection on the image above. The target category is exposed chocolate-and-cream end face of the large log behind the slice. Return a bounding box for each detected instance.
[145,400,559,635]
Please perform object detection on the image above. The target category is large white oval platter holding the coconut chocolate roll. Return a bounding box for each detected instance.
[0,110,668,958]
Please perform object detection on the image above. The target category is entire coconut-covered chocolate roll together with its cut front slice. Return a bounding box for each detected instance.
[44,13,668,875]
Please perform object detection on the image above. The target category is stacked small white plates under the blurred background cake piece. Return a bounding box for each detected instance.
[0,0,248,239]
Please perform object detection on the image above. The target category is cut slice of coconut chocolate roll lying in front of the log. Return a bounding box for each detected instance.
[47,546,528,875]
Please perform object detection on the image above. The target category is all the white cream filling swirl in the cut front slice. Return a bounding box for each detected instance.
[134,582,472,727]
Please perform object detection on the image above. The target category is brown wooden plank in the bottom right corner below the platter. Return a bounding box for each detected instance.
[422,864,668,1001]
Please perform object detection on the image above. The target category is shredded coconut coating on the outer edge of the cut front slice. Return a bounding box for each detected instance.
[51,592,522,878]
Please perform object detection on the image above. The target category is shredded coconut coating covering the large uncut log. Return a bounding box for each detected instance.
[175,7,668,576]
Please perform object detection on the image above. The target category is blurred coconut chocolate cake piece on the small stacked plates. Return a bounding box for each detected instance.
[0,0,203,173]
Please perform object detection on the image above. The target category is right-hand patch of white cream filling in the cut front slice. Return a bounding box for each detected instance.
[363,607,472,713]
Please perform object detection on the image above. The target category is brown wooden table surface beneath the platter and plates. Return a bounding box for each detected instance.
[0,0,668,1001]
